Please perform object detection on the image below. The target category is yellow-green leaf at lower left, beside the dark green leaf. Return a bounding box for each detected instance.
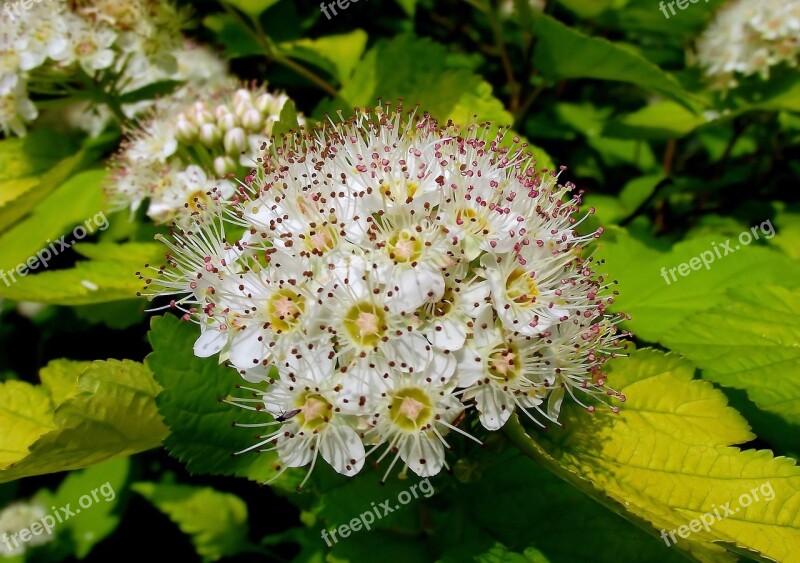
[0,360,167,483]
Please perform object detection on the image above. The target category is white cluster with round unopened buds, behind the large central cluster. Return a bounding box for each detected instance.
[107,83,298,223]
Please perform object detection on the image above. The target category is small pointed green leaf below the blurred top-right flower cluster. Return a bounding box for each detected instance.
[603,100,708,141]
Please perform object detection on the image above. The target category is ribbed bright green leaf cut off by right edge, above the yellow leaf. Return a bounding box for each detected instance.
[663,286,800,428]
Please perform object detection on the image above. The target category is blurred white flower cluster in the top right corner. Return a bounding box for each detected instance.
[696,0,800,88]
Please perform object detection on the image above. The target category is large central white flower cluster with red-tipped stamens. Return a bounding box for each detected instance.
[147,107,624,486]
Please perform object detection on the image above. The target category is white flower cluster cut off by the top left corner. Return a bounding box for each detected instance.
[0,0,192,135]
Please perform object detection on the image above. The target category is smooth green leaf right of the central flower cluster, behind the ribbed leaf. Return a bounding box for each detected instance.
[596,229,800,342]
